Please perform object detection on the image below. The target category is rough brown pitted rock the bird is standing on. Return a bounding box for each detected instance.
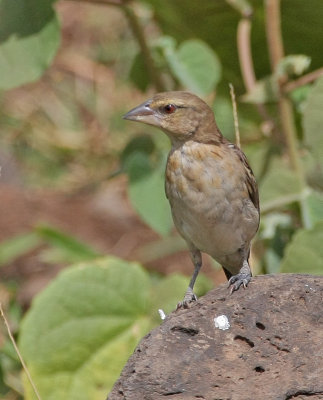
[108,274,323,400]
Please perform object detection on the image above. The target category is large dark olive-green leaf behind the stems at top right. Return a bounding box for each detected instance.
[146,0,323,90]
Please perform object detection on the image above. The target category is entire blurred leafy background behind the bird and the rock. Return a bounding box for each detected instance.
[0,0,323,400]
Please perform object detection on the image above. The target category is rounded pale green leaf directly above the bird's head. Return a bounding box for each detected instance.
[164,39,221,95]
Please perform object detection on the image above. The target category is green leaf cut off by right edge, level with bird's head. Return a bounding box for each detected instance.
[303,77,323,164]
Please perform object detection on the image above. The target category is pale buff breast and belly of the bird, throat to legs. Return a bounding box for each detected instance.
[165,141,257,258]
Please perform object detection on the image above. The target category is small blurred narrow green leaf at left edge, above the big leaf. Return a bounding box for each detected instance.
[0,233,41,266]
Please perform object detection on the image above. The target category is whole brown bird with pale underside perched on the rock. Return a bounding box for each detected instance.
[123,91,260,309]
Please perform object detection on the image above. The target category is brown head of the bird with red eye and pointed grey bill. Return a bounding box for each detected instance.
[123,91,218,143]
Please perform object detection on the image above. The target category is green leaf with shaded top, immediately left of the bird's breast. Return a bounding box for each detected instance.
[126,152,173,235]
